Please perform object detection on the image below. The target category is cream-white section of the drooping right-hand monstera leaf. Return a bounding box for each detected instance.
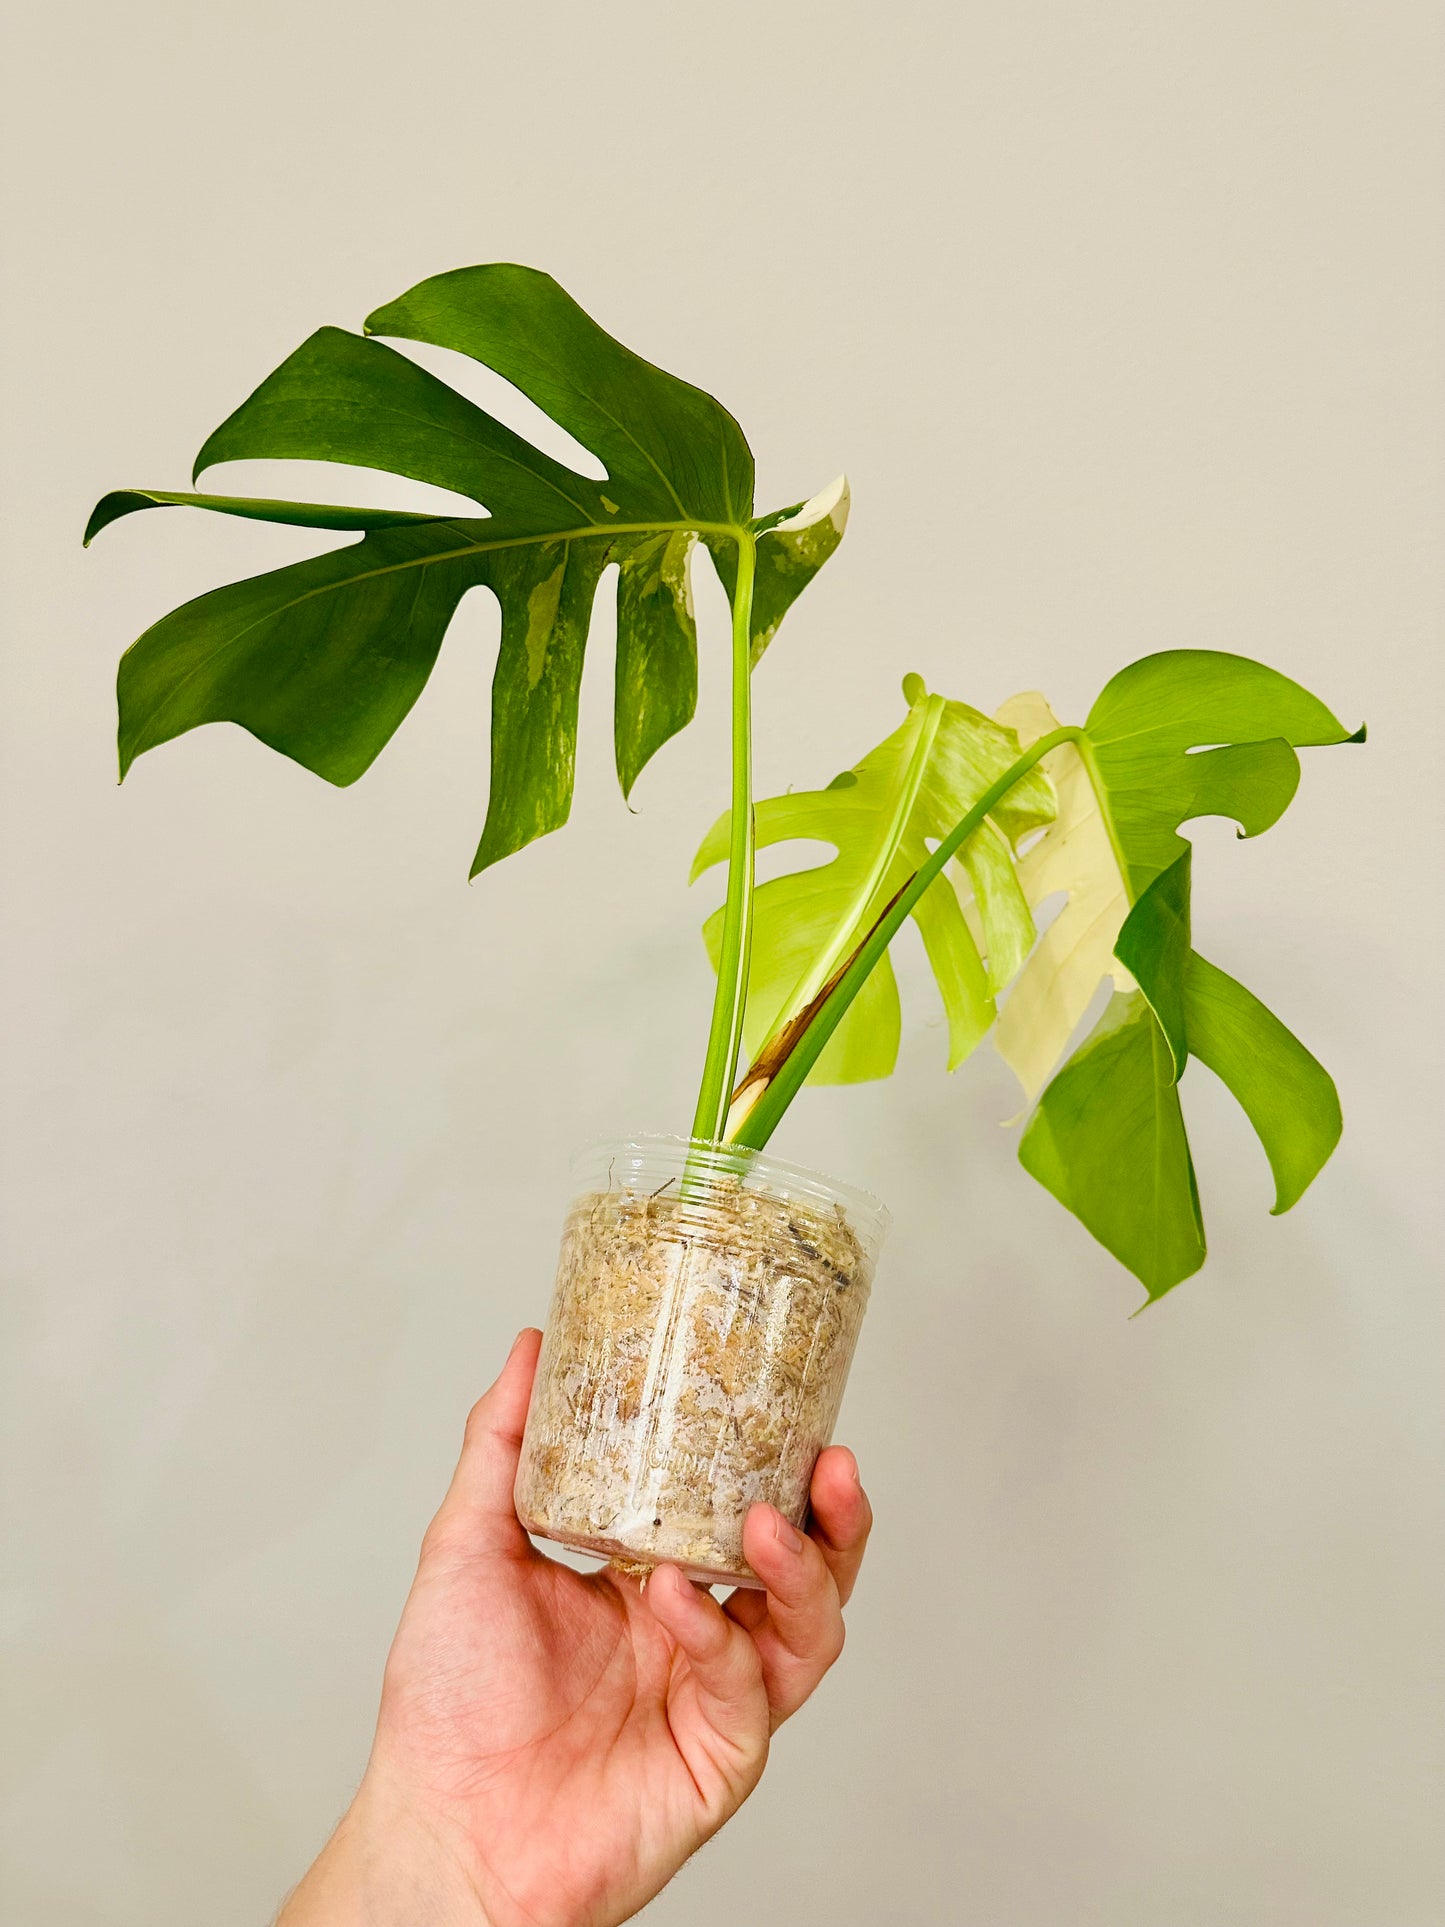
[994,692,1135,1098]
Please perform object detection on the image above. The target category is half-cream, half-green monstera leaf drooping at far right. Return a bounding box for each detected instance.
[998,649,1364,1299]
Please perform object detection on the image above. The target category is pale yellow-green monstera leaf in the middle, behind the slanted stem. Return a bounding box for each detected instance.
[692,676,1054,1083]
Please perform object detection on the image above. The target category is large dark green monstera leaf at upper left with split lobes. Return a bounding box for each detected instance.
[85,264,848,875]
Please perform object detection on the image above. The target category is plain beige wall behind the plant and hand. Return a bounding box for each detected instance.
[0,0,1445,1927]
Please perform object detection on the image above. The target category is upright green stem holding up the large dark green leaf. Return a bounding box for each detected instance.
[692,532,757,1141]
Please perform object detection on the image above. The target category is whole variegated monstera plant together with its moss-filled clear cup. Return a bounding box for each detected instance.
[87,266,1364,1586]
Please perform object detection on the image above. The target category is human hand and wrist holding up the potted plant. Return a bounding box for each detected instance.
[277,1332,871,1927]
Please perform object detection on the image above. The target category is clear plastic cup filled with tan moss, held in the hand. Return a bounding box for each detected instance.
[516,1137,888,1586]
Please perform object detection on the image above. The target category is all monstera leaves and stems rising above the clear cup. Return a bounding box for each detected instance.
[85,264,1364,1299]
